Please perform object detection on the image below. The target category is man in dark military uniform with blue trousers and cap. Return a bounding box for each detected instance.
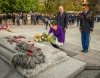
[80,4,94,53]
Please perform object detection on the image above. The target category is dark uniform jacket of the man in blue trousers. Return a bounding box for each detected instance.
[80,12,94,33]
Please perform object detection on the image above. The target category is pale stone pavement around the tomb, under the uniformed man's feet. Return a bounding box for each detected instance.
[0,23,100,78]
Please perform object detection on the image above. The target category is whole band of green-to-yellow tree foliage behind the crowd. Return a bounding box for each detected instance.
[0,0,81,14]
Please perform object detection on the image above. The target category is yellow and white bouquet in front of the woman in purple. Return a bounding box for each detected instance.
[34,32,56,43]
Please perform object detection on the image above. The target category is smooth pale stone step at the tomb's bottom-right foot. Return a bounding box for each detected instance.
[35,57,86,78]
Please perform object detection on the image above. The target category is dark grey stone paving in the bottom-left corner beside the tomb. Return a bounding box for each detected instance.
[0,56,24,78]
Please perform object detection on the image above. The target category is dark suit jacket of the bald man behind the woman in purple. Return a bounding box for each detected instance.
[56,12,68,29]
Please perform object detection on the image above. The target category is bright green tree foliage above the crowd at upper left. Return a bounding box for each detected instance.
[0,0,38,13]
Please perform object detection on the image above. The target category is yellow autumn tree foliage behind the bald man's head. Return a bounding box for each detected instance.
[38,0,81,14]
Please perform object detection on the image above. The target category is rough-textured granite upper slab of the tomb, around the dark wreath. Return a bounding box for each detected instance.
[0,34,69,77]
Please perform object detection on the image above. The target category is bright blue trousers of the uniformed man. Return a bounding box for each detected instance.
[81,33,90,51]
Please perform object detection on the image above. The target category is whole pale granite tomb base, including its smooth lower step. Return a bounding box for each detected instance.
[0,30,86,78]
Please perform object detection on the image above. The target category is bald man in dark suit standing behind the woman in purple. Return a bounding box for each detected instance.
[56,6,68,33]
